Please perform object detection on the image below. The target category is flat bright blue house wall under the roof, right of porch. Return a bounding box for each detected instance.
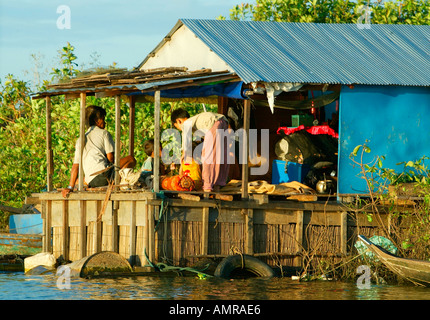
[338,85,430,194]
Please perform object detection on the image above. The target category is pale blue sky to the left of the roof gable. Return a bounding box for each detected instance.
[0,0,242,84]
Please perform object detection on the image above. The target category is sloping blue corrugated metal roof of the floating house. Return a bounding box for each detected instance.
[181,19,430,86]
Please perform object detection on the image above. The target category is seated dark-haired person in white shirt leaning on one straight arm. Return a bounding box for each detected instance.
[62,105,136,197]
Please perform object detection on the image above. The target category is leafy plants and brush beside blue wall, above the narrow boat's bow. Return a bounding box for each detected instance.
[350,142,430,259]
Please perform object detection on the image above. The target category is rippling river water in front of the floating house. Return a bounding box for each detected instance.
[0,272,430,300]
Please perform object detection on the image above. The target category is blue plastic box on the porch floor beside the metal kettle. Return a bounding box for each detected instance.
[272,160,310,184]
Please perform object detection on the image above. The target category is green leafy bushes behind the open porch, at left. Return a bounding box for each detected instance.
[0,43,216,229]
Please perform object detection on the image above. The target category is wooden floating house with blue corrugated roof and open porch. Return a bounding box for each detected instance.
[33,19,430,276]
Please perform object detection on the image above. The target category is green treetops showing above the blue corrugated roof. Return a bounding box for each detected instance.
[218,0,430,25]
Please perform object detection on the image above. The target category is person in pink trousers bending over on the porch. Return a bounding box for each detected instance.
[171,109,229,192]
